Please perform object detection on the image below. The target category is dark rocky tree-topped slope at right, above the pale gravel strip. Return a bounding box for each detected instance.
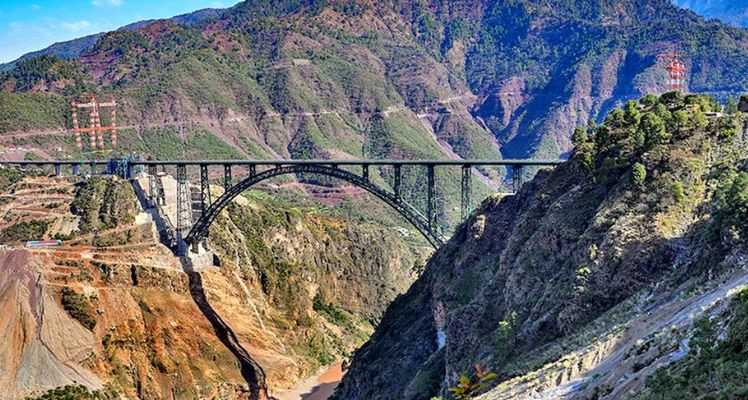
[336,93,748,400]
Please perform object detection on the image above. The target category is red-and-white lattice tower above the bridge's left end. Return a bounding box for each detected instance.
[71,95,117,151]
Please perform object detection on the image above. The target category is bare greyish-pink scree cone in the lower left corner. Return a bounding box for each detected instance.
[0,250,103,399]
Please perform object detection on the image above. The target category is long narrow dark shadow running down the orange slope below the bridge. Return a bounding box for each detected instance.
[182,258,272,400]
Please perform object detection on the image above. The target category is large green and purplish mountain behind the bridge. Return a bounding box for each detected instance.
[0,0,748,229]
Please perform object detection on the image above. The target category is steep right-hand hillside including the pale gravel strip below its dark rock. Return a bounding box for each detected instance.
[335,93,748,400]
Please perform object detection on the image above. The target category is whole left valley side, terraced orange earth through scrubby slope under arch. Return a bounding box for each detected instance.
[0,173,426,399]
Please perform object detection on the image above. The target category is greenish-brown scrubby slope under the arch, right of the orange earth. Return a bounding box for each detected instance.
[211,191,418,372]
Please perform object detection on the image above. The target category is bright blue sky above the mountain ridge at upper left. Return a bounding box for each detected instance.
[0,0,238,63]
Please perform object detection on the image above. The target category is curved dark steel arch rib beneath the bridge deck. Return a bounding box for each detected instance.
[184,164,446,248]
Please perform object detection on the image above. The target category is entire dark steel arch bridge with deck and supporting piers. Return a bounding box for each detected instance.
[0,158,563,253]
